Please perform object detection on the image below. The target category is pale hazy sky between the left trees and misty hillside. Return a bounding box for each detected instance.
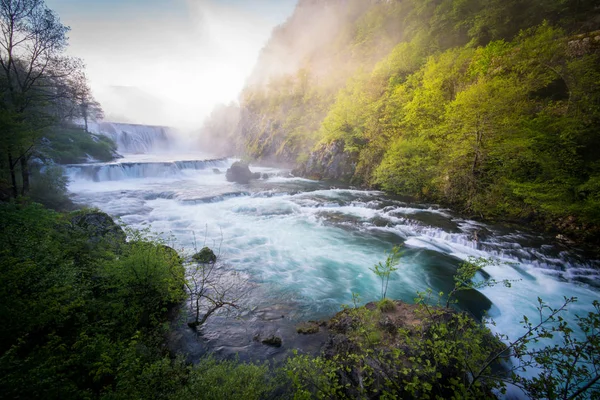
[46,0,296,129]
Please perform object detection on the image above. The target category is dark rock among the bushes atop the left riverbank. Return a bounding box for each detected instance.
[71,210,127,243]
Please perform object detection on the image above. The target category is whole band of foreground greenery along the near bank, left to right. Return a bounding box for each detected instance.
[0,203,600,399]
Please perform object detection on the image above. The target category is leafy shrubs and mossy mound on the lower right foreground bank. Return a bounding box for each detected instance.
[284,260,600,399]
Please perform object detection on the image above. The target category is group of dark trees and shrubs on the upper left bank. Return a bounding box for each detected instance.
[0,0,104,201]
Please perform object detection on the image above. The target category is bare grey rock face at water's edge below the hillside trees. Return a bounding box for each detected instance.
[294,140,356,182]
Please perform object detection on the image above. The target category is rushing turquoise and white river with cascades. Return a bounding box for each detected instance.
[66,122,600,368]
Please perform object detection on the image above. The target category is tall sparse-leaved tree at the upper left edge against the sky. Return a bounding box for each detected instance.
[0,0,82,197]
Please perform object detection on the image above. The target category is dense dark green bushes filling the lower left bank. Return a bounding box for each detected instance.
[0,204,184,398]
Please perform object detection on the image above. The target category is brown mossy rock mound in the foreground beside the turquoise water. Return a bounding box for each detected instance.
[322,300,504,399]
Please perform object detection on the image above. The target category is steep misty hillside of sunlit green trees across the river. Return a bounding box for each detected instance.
[207,0,600,238]
